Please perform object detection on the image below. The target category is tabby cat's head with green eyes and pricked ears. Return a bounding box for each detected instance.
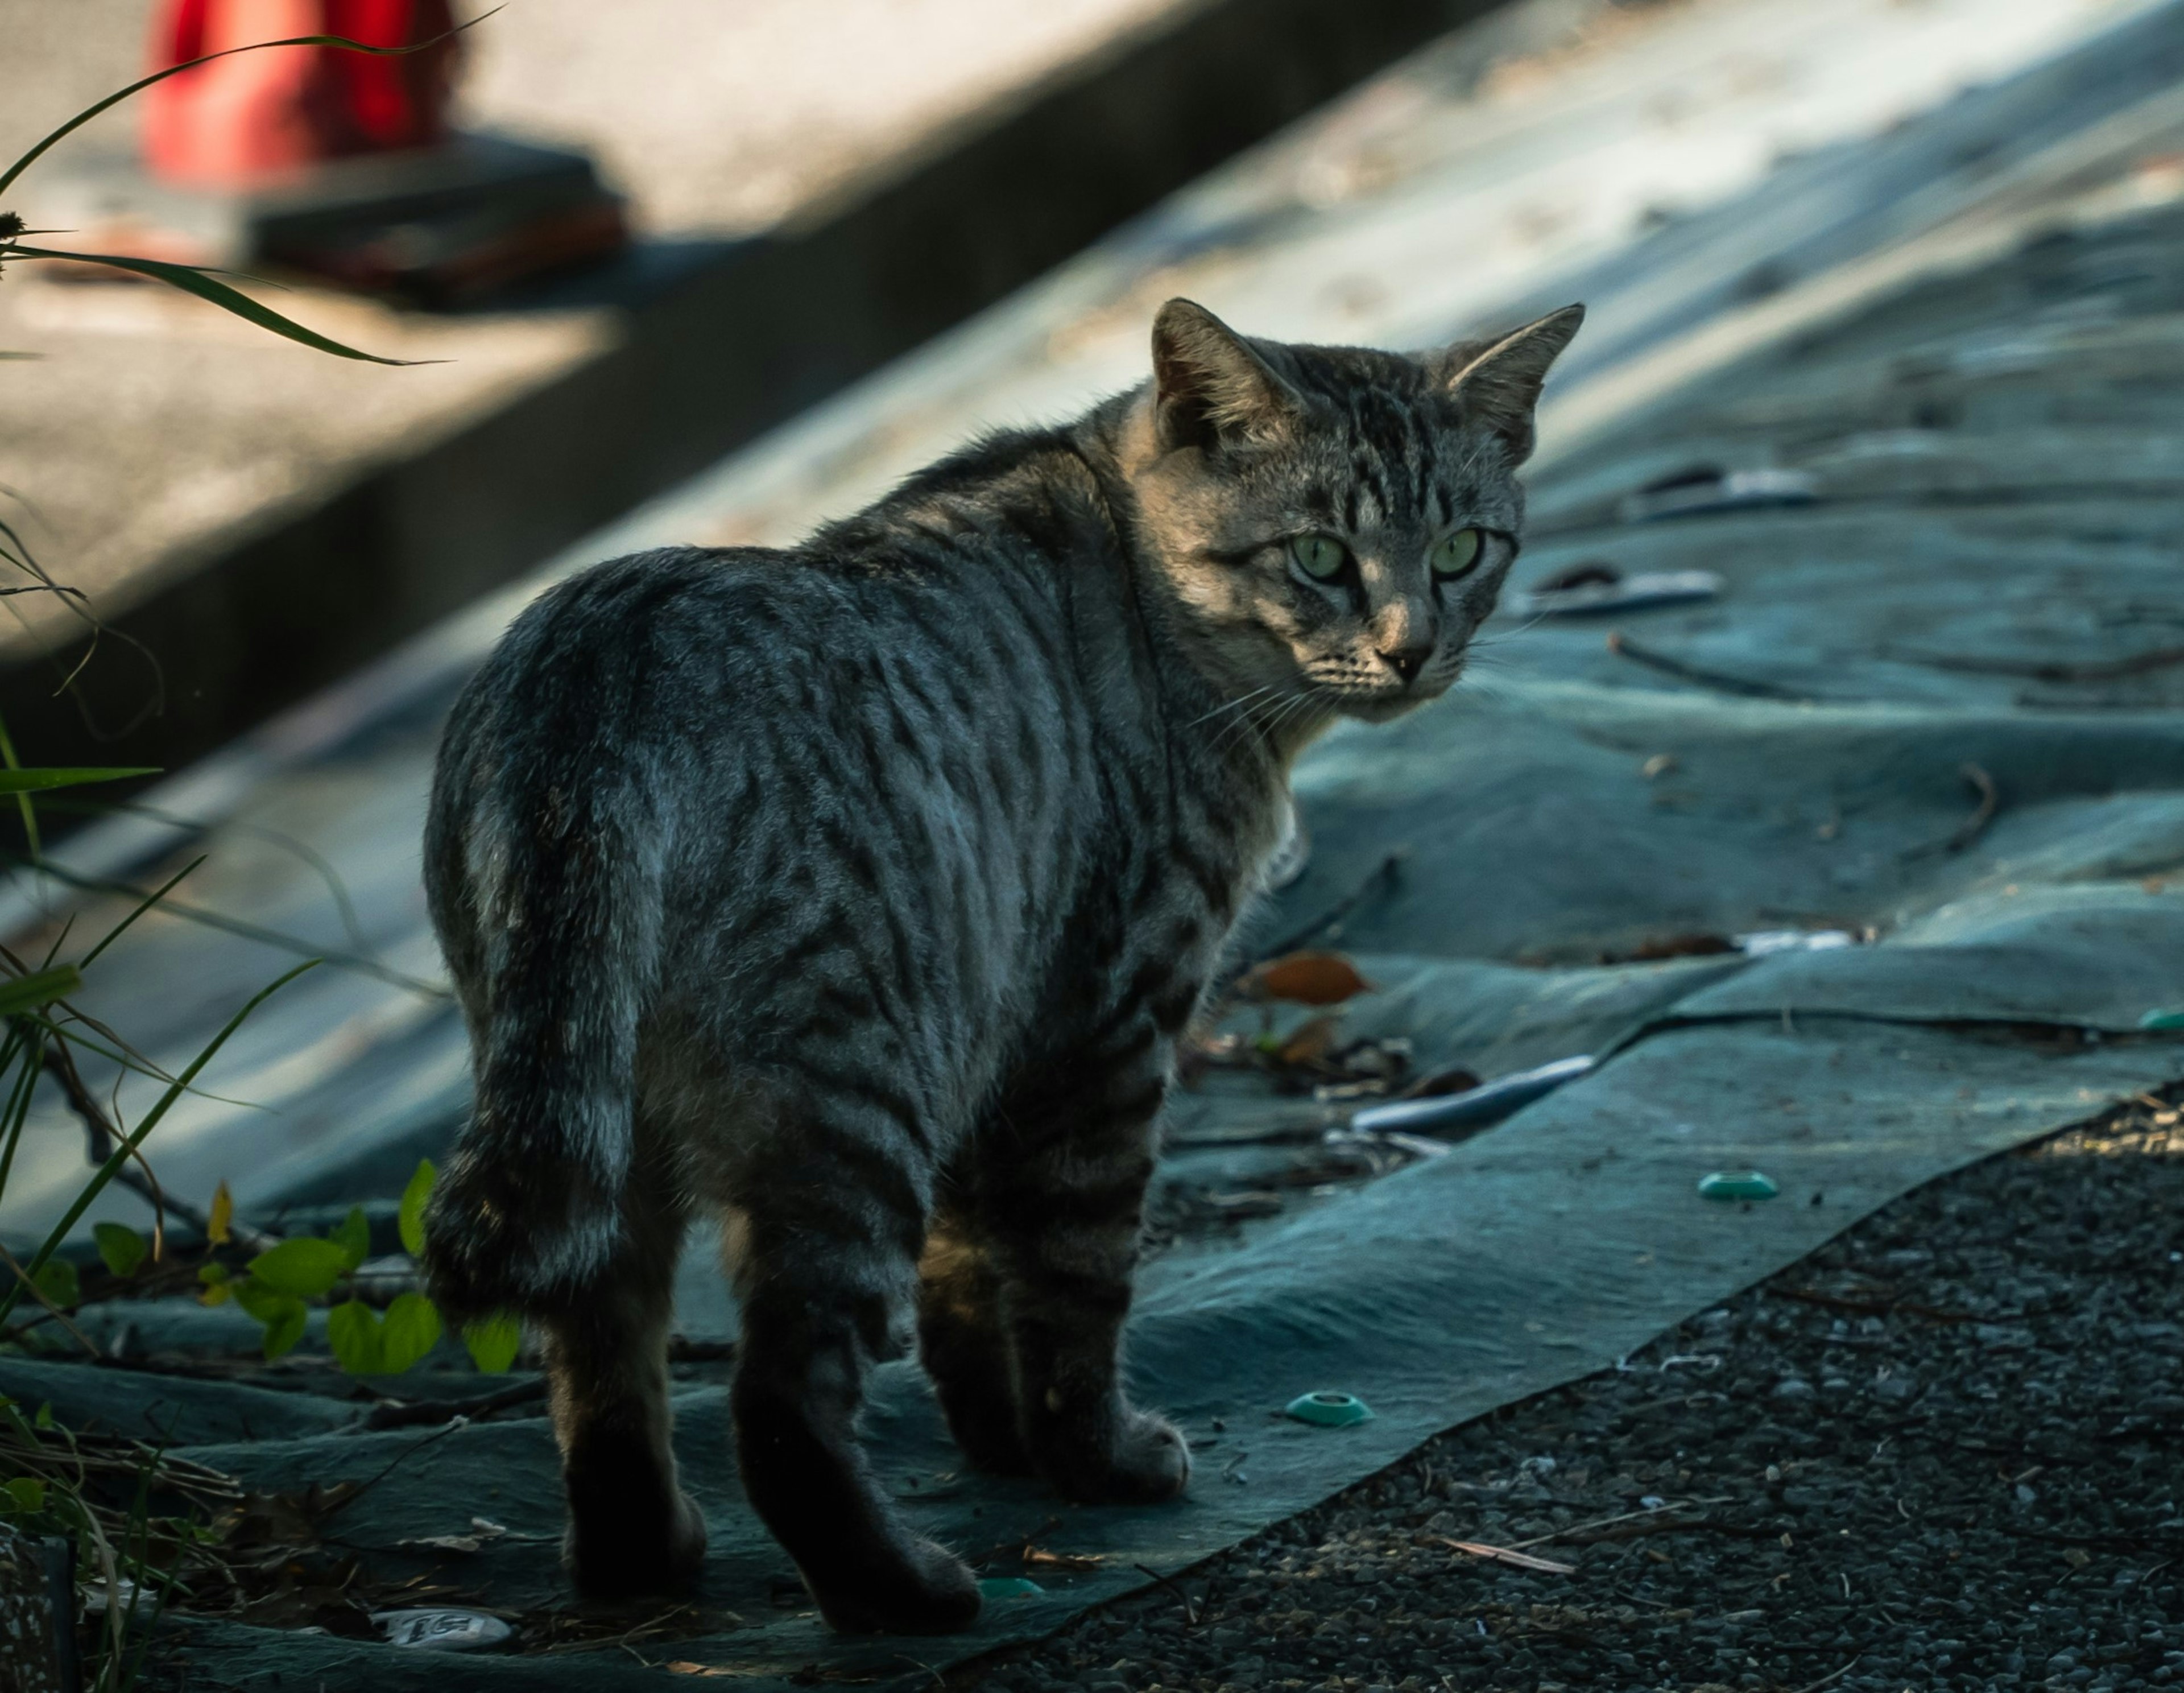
[1120,299,1586,730]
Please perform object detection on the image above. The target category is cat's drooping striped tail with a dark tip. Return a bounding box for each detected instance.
[424,760,664,1319]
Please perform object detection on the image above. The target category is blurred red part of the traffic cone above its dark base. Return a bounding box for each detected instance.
[144,0,458,188]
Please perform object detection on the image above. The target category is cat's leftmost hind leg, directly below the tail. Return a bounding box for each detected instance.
[535,1173,705,1599]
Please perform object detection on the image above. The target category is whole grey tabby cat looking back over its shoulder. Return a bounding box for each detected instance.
[426,299,1583,1632]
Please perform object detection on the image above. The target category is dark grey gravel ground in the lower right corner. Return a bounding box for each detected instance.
[950,1085,2184,1693]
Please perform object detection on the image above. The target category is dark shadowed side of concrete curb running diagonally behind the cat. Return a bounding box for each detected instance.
[17,0,1498,769]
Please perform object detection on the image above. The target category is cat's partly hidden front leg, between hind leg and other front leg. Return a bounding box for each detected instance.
[917,1204,1037,1475]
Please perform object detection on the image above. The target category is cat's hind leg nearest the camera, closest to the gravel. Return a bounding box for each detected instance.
[730,1103,978,1634]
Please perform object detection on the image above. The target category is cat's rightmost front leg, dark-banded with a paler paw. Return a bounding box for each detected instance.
[978,1031,1190,1503]
